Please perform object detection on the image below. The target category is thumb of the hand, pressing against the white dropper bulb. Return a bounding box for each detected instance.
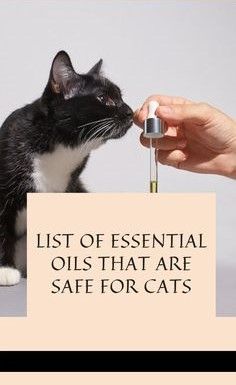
[157,103,213,125]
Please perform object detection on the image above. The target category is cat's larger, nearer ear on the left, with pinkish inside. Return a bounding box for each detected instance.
[50,51,76,96]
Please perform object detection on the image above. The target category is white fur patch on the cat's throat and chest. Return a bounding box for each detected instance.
[32,139,102,192]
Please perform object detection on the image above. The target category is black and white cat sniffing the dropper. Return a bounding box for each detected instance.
[0,51,133,285]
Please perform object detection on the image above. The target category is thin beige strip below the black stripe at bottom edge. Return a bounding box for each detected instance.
[0,373,236,385]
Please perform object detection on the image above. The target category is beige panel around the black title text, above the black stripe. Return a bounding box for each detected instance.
[0,194,236,350]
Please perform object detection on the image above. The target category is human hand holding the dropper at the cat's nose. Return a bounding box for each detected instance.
[134,95,236,178]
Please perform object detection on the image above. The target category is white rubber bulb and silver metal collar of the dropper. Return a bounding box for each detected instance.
[143,100,165,138]
